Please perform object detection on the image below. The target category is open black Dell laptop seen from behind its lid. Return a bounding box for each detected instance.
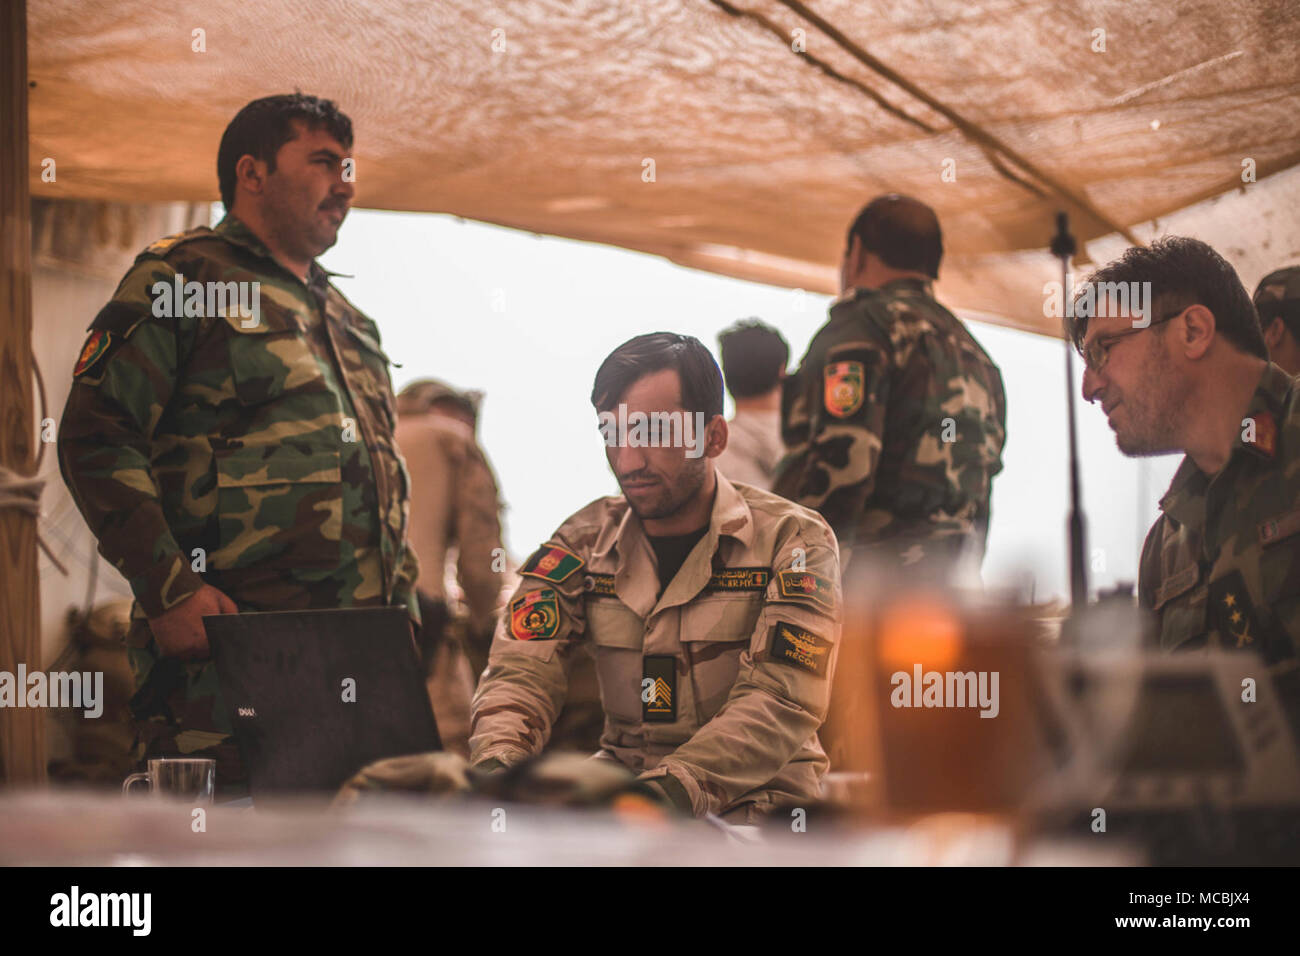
[203,607,442,800]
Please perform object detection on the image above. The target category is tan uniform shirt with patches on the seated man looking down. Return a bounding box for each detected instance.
[469,475,840,822]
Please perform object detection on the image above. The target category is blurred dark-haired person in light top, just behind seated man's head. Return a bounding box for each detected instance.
[715,319,790,492]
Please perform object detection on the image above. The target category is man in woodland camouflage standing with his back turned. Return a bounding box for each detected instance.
[774,195,1006,583]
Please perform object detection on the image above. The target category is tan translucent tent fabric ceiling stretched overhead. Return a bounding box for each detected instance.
[29,0,1300,334]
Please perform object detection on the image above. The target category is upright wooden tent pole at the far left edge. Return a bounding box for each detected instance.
[0,0,46,784]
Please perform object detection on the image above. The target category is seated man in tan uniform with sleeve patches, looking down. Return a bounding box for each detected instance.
[469,333,840,823]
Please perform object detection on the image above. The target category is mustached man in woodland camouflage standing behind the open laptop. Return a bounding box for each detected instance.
[59,94,419,786]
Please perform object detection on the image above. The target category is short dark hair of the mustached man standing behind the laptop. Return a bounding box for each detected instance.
[217,92,352,212]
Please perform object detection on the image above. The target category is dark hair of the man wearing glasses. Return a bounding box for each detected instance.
[1065,235,1269,359]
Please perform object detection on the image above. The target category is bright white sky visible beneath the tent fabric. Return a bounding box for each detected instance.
[299,209,1178,601]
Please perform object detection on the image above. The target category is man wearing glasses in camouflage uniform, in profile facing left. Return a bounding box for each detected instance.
[1069,237,1300,739]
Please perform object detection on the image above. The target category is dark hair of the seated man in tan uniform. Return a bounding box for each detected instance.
[592,332,723,420]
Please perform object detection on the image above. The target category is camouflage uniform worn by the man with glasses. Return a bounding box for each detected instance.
[1138,363,1300,741]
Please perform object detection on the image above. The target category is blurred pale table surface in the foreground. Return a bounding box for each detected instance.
[0,790,1140,866]
